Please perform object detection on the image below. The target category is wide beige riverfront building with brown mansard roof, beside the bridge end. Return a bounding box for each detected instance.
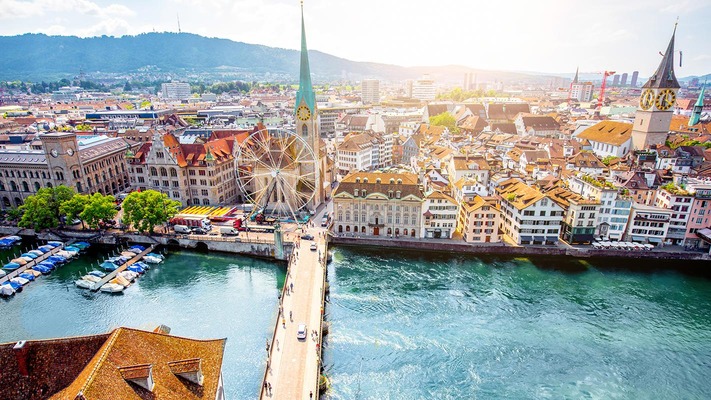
[333,172,424,237]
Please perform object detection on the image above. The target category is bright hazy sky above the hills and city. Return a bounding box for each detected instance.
[0,0,711,77]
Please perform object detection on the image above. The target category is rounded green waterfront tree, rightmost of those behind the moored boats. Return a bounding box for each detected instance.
[123,190,181,233]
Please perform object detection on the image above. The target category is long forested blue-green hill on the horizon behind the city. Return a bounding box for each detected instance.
[0,33,545,82]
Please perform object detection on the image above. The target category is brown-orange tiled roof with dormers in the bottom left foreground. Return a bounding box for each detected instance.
[0,328,227,400]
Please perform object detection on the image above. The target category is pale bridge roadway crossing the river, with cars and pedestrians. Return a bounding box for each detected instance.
[259,223,327,399]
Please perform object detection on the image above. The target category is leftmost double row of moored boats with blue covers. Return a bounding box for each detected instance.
[0,241,90,296]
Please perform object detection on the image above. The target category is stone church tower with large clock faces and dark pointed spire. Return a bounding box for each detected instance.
[632,25,680,150]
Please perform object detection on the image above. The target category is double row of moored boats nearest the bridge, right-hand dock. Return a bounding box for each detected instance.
[74,245,163,293]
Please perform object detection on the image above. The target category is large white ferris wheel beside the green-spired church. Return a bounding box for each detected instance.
[237,128,318,221]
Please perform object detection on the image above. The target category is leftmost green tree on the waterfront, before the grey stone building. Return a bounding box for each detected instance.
[18,185,75,229]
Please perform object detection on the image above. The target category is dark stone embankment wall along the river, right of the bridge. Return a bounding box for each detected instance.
[330,236,711,261]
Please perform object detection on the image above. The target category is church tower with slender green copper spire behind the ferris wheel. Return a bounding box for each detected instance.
[294,1,323,209]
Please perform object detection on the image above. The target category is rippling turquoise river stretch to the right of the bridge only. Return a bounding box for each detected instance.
[325,248,711,399]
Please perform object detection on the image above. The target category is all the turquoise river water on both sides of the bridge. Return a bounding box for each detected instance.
[0,242,711,400]
